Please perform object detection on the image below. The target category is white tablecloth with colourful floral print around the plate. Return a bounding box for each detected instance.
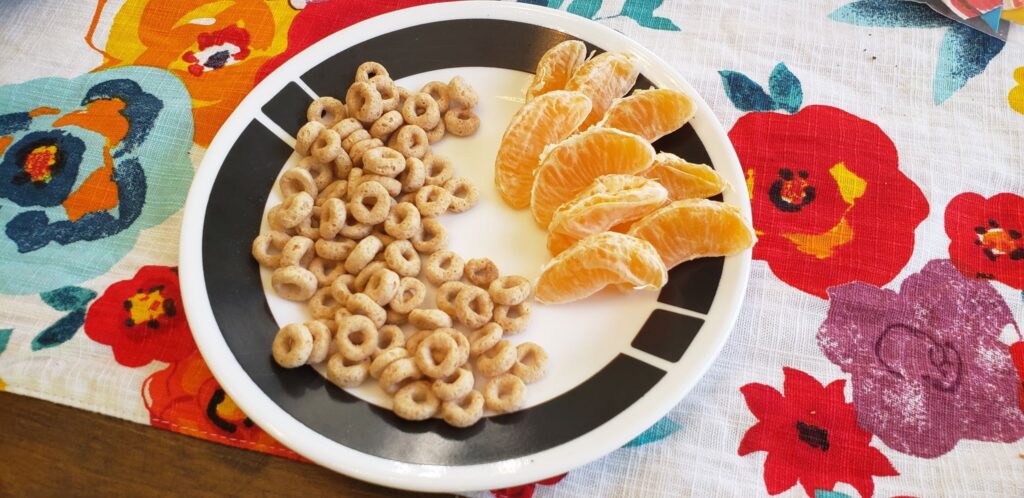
[0,0,1024,498]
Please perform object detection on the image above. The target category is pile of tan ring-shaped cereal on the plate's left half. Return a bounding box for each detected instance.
[252,61,548,427]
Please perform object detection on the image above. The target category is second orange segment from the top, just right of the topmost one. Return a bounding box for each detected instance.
[565,52,640,128]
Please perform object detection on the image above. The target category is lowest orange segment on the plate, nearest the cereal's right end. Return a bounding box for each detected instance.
[536,232,669,304]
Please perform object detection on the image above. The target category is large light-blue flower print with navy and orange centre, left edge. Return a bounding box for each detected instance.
[0,68,191,294]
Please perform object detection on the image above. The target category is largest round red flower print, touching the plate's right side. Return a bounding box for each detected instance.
[729,106,928,298]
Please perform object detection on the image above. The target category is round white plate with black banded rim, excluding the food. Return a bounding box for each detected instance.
[180,2,751,492]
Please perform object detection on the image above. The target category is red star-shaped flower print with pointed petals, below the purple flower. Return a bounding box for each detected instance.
[739,368,899,498]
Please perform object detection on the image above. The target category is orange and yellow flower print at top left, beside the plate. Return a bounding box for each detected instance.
[90,0,298,147]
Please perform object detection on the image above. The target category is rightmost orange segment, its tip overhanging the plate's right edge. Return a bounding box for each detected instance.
[629,199,757,268]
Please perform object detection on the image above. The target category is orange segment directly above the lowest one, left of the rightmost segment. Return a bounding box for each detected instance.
[548,174,669,255]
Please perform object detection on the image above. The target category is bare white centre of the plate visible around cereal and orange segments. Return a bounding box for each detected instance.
[261,68,657,408]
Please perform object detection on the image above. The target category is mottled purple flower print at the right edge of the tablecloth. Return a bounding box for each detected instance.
[817,260,1024,458]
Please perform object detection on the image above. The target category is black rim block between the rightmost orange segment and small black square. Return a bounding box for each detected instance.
[657,257,725,314]
